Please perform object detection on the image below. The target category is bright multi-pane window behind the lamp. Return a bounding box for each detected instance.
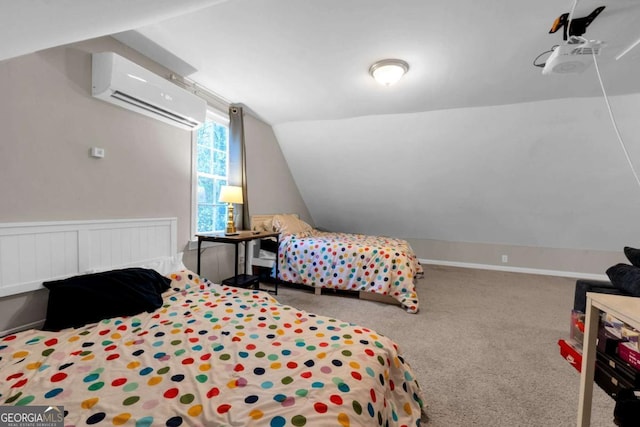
[193,112,230,234]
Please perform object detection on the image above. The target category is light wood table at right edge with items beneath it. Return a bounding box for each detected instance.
[578,292,640,427]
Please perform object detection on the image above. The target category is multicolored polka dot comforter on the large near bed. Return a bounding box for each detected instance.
[0,272,422,427]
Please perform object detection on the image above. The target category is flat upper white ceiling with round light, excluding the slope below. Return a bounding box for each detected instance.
[5,0,640,124]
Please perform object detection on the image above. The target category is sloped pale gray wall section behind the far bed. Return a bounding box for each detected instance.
[275,95,640,273]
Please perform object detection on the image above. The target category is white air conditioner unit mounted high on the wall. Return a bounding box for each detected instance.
[91,52,207,130]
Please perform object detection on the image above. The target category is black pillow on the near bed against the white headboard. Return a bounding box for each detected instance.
[43,268,171,331]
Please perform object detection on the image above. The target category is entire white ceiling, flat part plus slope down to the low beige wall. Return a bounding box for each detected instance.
[0,0,640,250]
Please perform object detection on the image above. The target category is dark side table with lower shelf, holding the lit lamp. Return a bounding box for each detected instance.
[196,231,280,295]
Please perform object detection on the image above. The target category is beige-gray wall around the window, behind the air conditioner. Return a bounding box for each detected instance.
[0,37,308,331]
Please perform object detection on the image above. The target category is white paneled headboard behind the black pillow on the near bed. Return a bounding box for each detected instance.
[0,218,178,297]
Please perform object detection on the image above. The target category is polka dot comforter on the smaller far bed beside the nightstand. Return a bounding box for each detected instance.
[278,230,423,313]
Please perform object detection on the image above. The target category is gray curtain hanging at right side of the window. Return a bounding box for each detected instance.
[229,105,250,230]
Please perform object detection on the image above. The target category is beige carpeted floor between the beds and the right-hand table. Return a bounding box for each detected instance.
[264,266,614,427]
